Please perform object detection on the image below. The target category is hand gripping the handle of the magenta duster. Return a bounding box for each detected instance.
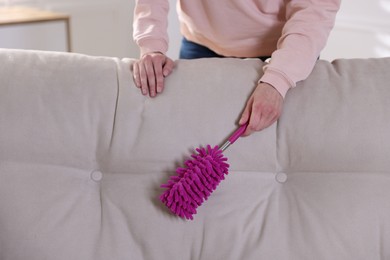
[239,83,283,136]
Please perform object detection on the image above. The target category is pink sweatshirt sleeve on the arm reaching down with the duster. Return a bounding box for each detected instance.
[259,0,341,97]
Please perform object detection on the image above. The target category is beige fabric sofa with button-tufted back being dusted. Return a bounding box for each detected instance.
[0,50,390,260]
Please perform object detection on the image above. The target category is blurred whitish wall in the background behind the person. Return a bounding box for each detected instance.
[0,0,390,60]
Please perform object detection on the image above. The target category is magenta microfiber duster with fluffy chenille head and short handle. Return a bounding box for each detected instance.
[160,125,246,219]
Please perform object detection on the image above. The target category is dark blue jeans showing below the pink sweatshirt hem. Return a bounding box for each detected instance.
[179,37,270,61]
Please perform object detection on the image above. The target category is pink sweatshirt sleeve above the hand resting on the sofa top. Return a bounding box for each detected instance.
[133,0,169,55]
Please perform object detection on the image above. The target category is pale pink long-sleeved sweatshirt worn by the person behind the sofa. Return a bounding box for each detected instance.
[133,0,341,97]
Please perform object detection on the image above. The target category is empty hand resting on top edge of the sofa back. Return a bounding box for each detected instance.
[133,52,175,97]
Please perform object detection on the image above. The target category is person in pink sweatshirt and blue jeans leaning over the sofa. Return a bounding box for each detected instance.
[133,0,341,135]
